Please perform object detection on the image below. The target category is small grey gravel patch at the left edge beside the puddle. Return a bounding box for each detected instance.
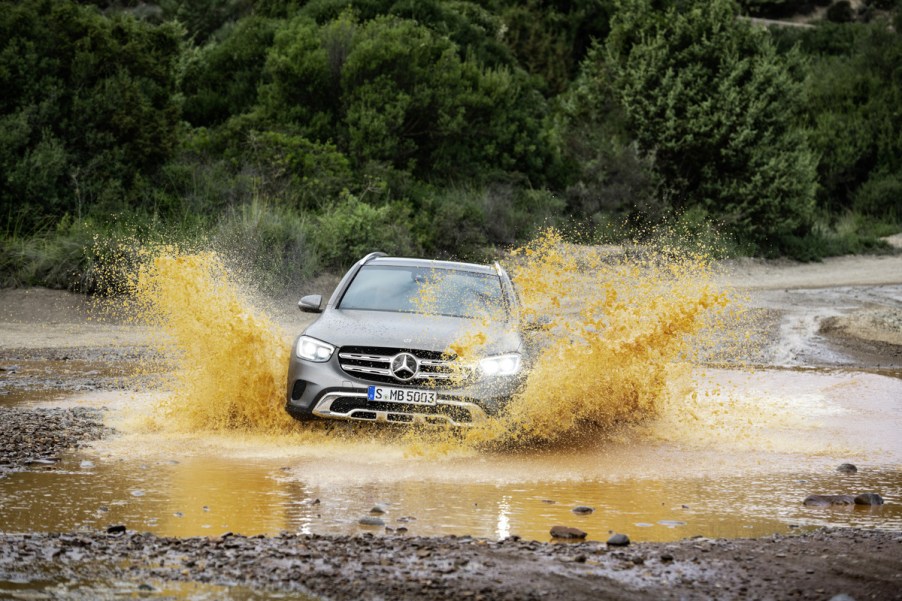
[0,407,112,478]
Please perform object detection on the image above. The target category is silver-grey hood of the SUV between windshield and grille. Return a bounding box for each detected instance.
[304,309,520,355]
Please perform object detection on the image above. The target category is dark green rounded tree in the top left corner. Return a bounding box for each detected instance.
[0,0,180,228]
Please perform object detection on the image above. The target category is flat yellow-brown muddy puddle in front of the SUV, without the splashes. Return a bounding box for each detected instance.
[0,370,902,541]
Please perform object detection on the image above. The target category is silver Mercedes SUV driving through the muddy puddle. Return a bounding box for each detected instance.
[286,253,528,426]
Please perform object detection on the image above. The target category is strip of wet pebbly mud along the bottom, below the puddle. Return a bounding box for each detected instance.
[0,529,902,601]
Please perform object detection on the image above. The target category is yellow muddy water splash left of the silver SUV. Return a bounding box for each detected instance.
[130,247,294,432]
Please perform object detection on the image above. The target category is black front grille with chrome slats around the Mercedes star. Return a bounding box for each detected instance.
[338,346,466,388]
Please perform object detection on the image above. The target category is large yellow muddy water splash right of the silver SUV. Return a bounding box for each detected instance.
[460,230,729,443]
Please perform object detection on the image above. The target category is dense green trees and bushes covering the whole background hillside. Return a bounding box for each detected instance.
[0,0,902,292]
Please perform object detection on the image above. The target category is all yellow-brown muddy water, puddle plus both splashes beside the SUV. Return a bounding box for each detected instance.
[0,238,902,541]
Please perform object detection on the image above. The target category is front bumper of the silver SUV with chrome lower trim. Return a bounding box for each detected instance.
[285,353,524,426]
